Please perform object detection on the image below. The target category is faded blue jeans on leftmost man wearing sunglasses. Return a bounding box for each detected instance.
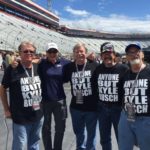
[12,119,43,150]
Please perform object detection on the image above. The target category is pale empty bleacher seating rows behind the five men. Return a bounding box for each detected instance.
[0,12,150,54]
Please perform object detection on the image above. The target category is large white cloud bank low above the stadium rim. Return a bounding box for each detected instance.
[60,13,150,33]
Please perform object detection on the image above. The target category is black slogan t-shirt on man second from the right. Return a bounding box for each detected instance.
[92,64,128,106]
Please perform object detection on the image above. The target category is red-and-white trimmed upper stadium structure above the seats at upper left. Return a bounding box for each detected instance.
[0,0,59,27]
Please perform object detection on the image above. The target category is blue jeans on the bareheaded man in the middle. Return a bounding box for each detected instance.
[70,108,97,150]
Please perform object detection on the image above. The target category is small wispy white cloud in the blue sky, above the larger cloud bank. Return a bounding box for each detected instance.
[64,6,90,17]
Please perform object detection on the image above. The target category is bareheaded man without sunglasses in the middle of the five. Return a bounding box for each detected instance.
[64,43,97,150]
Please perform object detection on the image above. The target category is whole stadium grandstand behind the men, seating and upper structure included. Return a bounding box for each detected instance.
[0,0,150,54]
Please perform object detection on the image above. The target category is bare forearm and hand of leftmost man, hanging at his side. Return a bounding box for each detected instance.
[0,85,11,118]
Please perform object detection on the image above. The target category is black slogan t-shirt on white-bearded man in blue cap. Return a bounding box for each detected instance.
[120,65,150,116]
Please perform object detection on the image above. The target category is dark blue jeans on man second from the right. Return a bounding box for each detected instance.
[98,104,121,150]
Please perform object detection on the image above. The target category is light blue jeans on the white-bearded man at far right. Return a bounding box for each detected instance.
[118,111,150,150]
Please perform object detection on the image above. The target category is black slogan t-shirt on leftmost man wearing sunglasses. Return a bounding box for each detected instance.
[2,64,42,124]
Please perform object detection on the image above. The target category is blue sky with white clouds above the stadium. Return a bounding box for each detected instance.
[33,0,150,33]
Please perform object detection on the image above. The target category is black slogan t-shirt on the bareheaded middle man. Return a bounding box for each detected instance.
[64,61,98,111]
